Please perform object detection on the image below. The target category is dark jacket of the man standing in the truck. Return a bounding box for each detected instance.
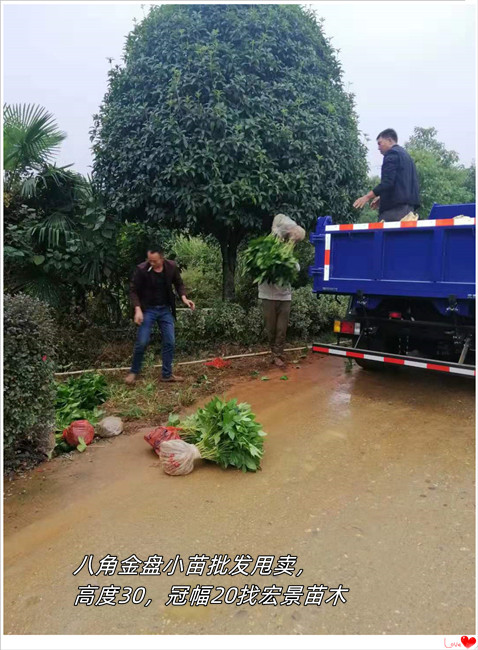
[373,144,420,213]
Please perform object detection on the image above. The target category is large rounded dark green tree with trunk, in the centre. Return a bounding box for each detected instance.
[92,5,366,298]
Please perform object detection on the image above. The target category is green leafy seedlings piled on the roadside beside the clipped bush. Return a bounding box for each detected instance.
[55,373,108,451]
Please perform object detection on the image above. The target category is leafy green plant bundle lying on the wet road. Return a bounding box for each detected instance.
[169,397,266,472]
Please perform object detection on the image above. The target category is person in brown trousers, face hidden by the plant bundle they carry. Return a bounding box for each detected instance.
[259,214,305,368]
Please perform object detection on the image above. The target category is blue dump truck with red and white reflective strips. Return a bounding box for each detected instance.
[309,203,476,377]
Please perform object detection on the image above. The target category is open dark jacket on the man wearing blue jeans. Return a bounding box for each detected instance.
[129,260,186,318]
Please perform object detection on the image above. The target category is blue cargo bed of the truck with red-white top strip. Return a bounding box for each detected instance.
[310,204,475,300]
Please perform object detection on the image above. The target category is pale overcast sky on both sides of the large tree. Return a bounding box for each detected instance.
[2,0,476,173]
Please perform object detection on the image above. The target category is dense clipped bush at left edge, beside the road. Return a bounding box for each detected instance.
[3,294,56,471]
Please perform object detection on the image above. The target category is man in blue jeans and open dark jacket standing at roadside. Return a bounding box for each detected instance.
[125,246,195,384]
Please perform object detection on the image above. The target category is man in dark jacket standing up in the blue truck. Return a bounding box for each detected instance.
[354,129,420,221]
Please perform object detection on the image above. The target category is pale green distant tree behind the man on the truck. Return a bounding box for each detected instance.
[405,127,476,218]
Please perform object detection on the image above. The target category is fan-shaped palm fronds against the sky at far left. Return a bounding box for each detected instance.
[3,104,71,197]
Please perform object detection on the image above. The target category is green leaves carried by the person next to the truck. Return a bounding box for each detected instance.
[244,235,297,286]
